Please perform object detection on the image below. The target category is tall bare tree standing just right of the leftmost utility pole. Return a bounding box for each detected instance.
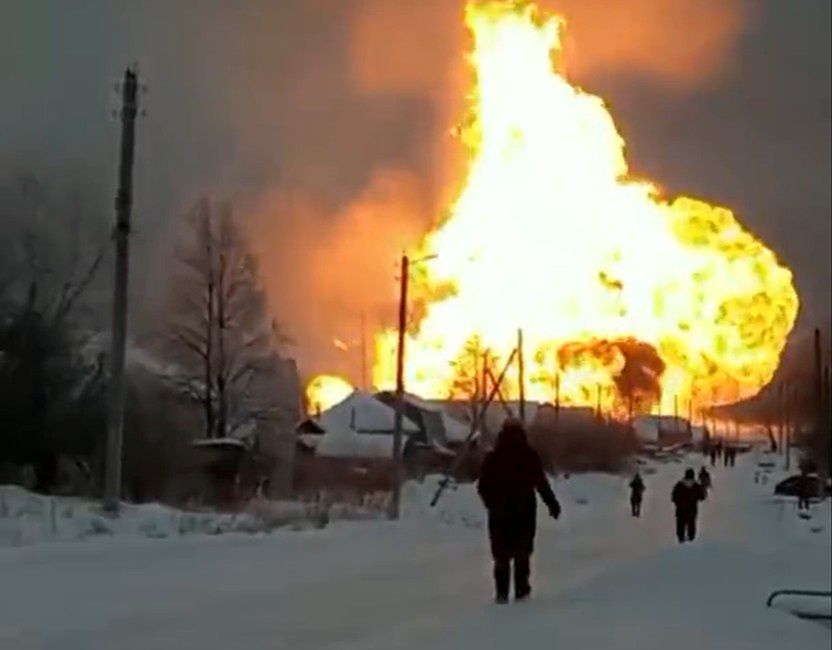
[167,199,285,438]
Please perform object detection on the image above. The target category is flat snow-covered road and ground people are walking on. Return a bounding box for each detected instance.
[0,454,832,650]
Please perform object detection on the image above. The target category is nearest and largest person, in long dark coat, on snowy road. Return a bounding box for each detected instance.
[477,419,560,603]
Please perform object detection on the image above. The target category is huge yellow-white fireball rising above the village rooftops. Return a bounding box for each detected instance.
[374,2,798,411]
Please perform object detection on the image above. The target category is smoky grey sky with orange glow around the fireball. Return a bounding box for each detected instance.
[0,0,830,374]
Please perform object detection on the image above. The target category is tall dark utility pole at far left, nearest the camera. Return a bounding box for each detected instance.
[104,68,138,514]
